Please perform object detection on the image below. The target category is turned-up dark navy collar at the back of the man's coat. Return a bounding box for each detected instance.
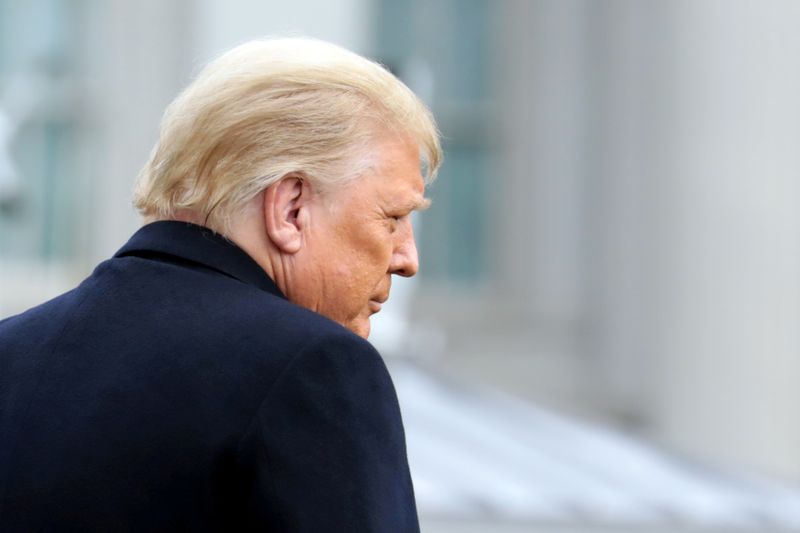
[114,220,285,298]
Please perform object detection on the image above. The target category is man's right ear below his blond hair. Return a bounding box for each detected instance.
[264,174,311,254]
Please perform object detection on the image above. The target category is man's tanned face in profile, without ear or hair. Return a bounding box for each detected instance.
[290,139,429,338]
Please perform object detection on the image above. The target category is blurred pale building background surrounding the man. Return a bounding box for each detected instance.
[0,0,800,532]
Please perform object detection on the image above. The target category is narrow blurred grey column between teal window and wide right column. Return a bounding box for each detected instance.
[488,0,585,328]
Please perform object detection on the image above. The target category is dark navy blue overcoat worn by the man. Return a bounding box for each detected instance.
[0,222,419,532]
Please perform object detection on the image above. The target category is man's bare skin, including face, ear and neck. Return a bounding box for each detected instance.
[231,136,429,338]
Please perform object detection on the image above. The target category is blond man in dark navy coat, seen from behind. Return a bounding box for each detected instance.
[0,39,441,532]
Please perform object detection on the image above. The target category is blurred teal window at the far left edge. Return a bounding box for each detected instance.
[0,0,85,260]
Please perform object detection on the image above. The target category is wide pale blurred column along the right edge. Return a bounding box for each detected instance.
[584,0,800,477]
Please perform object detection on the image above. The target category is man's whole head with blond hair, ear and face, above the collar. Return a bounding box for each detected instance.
[135,39,441,337]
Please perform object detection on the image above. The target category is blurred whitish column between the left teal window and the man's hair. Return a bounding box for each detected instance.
[82,0,192,265]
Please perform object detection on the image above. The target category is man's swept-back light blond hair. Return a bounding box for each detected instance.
[134,38,442,233]
